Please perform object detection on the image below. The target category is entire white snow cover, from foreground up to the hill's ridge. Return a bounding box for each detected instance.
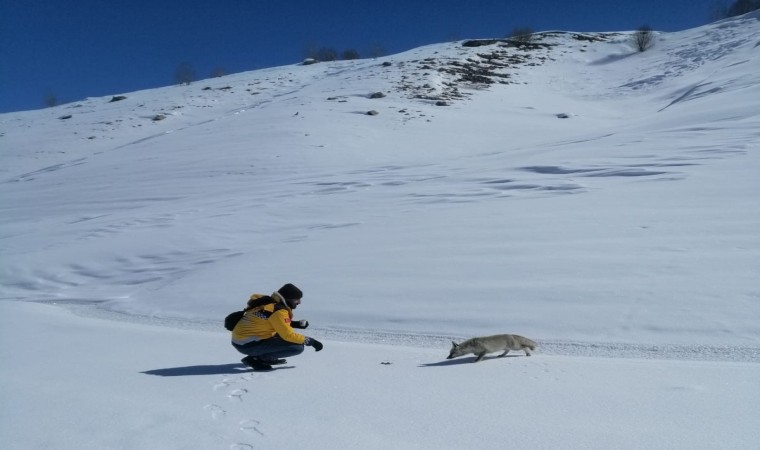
[0,13,760,449]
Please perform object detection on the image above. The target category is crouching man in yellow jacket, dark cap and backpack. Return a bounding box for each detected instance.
[232,283,322,370]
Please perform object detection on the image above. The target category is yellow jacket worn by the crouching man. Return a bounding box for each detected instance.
[232,292,306,345]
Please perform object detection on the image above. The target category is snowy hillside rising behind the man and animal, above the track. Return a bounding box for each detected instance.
[0,17,760,343]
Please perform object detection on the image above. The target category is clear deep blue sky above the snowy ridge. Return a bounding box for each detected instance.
[0,0,715,112]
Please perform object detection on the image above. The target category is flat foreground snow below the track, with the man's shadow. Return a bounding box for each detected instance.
[0,302,760,450]
